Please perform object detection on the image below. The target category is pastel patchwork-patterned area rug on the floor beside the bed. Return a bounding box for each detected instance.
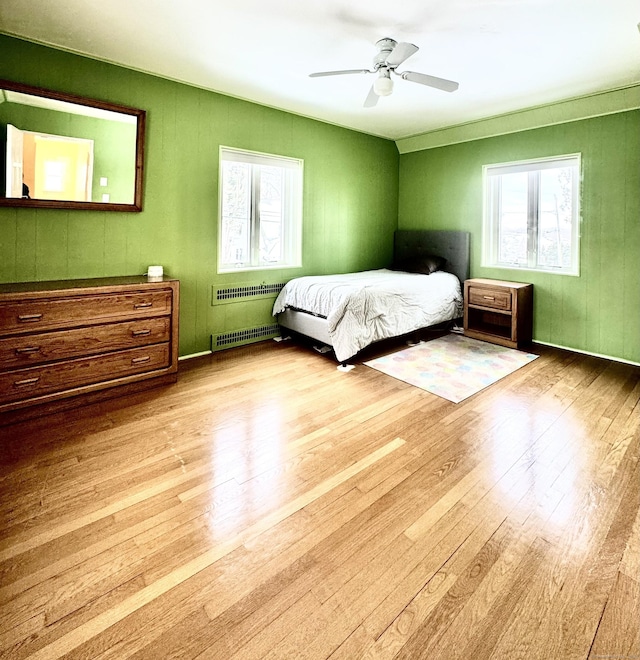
[364,334,538,403]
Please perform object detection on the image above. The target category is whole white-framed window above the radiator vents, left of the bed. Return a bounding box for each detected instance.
[218,147,302,272]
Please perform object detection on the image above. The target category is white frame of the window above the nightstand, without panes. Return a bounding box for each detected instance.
[482,153,582,276]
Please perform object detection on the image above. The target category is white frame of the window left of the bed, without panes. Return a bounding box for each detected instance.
[218,146,304,273]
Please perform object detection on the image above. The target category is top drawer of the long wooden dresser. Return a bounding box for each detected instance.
[0,289,171,335]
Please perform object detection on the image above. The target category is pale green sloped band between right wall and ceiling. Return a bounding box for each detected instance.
[396,83,640,154]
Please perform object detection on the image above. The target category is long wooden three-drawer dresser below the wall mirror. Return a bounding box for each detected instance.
[0,276,179,417]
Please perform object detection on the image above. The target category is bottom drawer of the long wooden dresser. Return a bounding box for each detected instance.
[0,343,170,403]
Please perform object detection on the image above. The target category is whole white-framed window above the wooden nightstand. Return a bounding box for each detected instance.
[483,154,580,275]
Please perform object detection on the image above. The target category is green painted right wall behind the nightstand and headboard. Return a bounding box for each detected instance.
[398,110,640,362]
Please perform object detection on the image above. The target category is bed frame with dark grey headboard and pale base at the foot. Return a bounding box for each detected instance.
[278,230,470,358]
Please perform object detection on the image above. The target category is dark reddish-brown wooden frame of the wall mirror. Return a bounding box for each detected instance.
[0,80,146,212]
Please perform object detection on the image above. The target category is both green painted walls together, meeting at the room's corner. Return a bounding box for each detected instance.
[0,35,640,362]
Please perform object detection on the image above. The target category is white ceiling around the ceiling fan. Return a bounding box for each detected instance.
[0,0,640,139]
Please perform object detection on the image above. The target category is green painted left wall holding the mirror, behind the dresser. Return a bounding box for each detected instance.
[0,35,399,355]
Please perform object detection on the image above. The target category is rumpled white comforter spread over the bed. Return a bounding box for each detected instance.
[273,269,462,362]
